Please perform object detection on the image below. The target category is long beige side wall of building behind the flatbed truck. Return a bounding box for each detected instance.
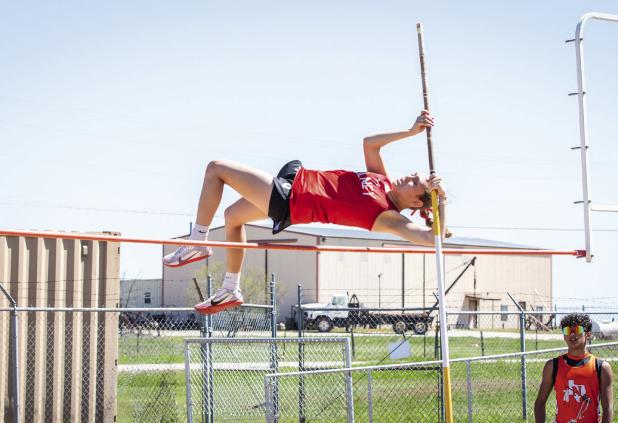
[319,238,552,320]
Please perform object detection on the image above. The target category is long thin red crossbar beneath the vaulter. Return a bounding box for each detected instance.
[0,229,586,257]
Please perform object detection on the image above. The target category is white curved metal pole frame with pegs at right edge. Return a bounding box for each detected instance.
[569,12,618,263]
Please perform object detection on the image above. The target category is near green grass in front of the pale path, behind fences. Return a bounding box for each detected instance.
[118,363,552,423]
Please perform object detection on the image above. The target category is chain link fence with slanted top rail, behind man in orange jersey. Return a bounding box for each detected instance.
[265,342,618,423]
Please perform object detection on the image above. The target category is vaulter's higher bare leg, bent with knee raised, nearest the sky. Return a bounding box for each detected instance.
[195,160,273,227]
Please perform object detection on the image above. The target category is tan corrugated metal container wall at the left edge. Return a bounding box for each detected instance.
[0,233,120,423]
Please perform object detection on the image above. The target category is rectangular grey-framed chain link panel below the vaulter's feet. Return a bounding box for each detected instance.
[184,336,354,423]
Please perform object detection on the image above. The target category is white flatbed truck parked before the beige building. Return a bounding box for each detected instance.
[301,294,433,335]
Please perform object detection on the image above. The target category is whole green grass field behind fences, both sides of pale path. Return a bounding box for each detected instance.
[113,332,604,422]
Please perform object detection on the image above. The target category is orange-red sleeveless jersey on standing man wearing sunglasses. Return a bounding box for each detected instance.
[554,354,601,423]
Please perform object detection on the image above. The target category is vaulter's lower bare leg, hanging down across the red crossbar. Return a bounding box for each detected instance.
[225,198,270,273]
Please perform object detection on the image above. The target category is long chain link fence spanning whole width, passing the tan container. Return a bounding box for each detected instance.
[0,294,618,423]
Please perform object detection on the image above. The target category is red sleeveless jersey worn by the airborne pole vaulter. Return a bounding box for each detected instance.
[290,168,396,230]
